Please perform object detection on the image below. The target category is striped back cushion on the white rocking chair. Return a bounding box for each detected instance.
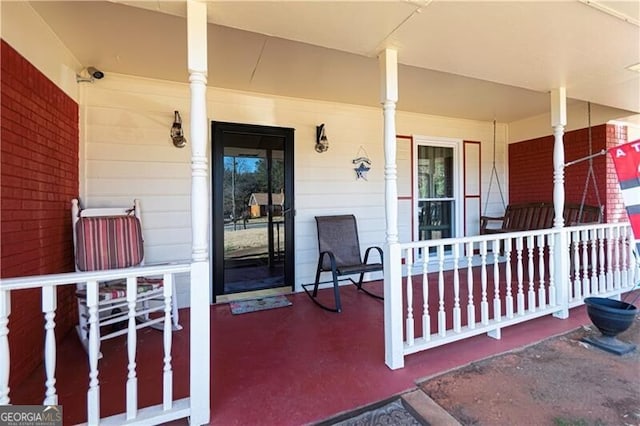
[76,216,144,271]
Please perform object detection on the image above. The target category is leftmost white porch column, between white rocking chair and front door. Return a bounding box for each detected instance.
[188,0,211,425]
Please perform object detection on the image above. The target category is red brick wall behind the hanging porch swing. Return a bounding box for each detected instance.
[509,124,612,216]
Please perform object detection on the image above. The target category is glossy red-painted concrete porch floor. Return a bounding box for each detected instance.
[10,283,589,426]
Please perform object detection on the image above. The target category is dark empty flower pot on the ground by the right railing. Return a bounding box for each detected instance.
[582,297,638,355]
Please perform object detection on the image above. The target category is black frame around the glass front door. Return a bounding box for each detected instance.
[211,121,295,303]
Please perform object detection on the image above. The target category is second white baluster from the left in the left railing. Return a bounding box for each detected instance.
[42,286,58,405]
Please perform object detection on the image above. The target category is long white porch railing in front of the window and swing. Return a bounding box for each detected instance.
[385,223,640,369]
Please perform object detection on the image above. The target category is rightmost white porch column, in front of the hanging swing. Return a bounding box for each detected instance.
[551,87,570,318]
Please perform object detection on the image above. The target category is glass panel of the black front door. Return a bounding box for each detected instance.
[223,143,285,294]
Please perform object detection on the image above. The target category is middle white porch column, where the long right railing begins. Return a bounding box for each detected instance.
[378,49,404,369]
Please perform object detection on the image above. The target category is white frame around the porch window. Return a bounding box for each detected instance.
[411,135,464,245]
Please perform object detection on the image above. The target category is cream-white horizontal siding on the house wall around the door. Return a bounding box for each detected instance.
[81,74,506,306]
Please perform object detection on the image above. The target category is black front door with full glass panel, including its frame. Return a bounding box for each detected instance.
[211,122,294,295]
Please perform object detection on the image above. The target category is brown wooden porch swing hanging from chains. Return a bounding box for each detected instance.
[480,103,606,235]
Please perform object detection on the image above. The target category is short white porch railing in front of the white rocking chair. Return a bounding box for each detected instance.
[0,263,198,425]
